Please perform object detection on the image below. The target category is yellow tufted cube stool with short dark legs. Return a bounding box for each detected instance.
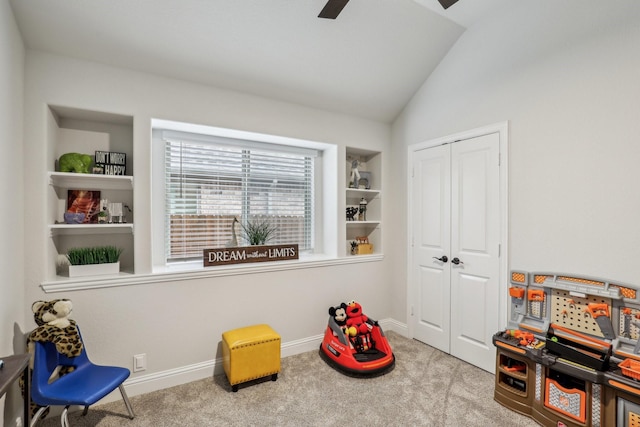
[222,325,280,392]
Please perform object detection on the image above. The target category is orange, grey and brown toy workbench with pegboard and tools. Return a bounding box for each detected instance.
[493,271,640,427]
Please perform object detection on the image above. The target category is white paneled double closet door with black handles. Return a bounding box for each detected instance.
[408,133,501,372]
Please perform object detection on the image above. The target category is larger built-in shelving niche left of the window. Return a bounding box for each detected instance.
[44,106,135,281]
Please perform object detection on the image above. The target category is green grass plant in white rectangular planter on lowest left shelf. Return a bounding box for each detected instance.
[66,246,122,277]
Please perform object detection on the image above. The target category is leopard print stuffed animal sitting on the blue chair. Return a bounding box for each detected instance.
[20,299,83,418]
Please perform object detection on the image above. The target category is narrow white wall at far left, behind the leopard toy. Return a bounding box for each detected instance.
[0,2,25,425]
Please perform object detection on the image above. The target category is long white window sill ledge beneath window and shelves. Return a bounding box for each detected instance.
[40,254,384,293]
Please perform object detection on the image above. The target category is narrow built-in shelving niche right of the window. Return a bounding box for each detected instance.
[344,147,383,256]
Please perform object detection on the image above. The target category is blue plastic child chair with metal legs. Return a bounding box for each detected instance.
[31,328,135,427]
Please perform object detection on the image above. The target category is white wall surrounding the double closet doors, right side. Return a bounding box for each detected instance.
[387,0,640,319]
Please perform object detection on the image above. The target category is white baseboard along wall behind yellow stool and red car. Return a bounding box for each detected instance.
[100,319,408,410]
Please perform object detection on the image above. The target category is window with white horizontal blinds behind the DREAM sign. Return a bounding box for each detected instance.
[163,131,315,262]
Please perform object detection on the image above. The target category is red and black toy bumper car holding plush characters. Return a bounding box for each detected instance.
[320,303,396,376]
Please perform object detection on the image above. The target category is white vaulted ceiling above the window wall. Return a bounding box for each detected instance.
[10,0,509,122]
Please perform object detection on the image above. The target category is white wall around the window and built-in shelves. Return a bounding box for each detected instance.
[24,51,391,393]
